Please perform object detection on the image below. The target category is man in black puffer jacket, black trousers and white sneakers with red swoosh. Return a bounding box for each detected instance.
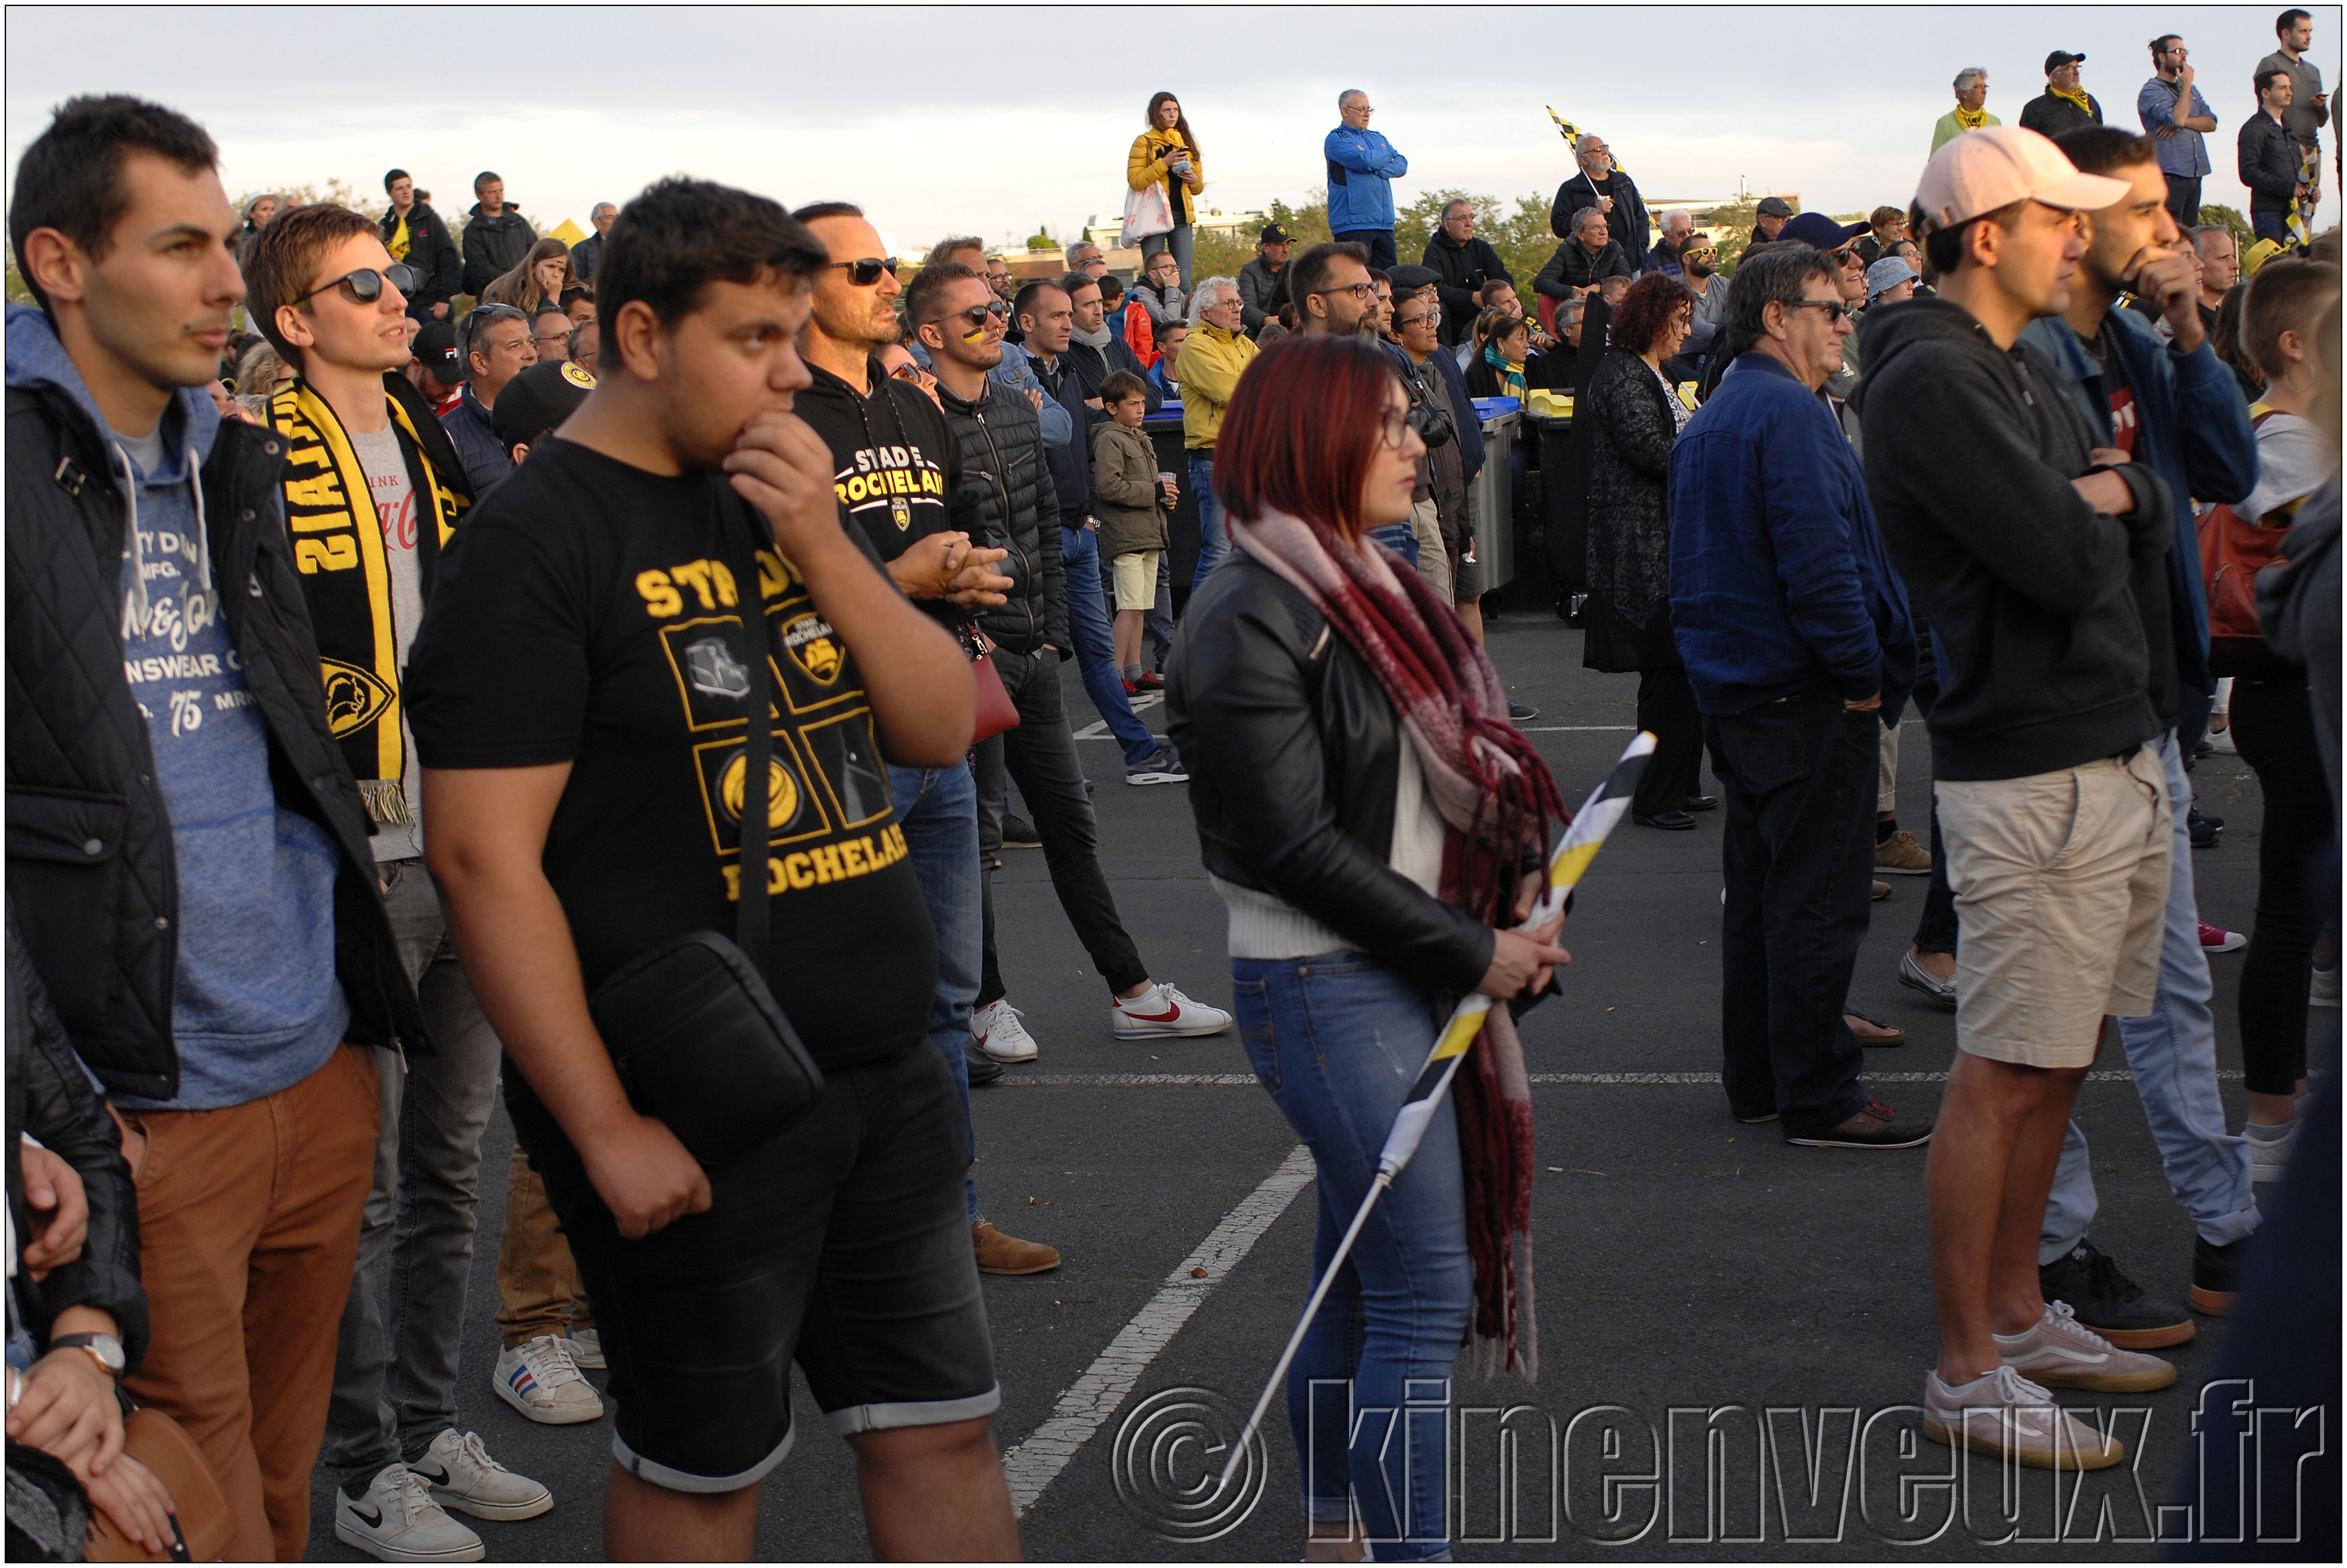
[906,265,1230,1061]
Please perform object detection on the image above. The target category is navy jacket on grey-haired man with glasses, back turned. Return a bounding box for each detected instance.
[1671,355,1915,718]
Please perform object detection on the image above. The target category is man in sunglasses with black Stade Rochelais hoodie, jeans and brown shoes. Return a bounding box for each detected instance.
[791,215,1059,1274]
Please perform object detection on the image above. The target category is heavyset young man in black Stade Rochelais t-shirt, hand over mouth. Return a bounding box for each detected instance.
[408,178,1019,1559]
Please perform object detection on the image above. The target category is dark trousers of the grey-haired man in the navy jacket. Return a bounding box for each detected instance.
[1704,688,1882,1136]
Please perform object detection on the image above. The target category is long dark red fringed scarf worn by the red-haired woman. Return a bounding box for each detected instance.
[1225,511,1570,1378]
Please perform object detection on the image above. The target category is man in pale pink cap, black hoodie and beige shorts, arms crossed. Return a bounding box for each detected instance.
[1854,127,2173,1469]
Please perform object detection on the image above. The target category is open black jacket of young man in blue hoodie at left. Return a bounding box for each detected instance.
[7,385,430,1101]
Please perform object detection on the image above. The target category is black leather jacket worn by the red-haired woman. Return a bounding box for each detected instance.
[1167,554,1493,993]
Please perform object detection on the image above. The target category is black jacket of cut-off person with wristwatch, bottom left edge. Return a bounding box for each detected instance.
[7,899,148,1366]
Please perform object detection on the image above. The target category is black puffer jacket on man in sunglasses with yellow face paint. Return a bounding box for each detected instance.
[937,380,1084,660]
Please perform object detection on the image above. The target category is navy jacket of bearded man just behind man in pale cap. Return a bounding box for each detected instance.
[2021,310,2258,695]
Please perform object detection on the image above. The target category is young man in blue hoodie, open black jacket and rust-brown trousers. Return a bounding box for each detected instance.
[7,97,430,1561]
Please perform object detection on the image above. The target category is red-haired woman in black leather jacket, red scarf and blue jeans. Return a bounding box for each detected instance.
[1167,338,1570,1561]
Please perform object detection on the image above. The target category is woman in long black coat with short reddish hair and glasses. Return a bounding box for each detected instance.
[1575,272,1713,829]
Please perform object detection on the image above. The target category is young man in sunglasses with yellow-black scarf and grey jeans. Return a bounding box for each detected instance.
[244,204,554,1563]
